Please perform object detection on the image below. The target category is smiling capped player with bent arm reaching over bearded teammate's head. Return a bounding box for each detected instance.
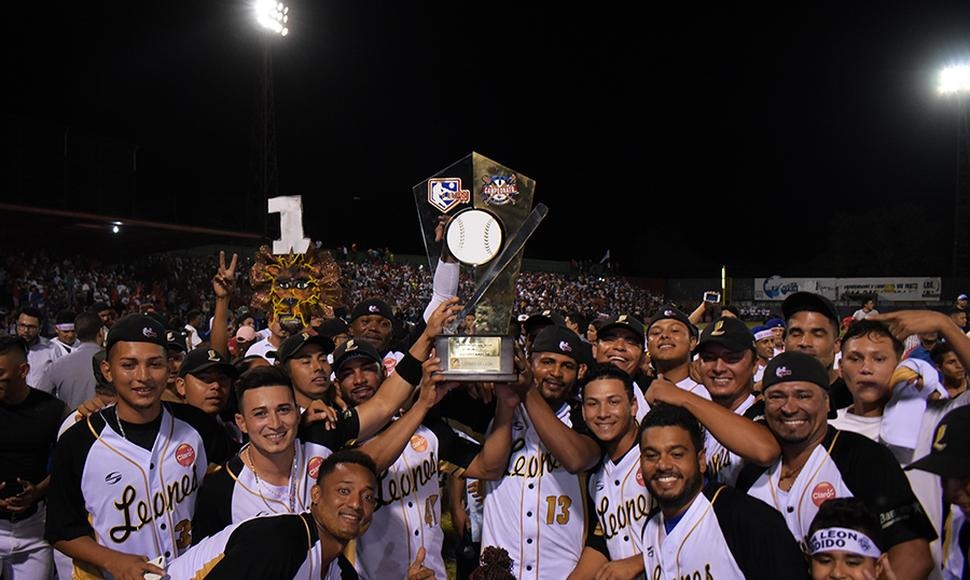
[647,317,781,484]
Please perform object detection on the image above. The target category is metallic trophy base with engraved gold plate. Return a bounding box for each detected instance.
[435,335,518,383]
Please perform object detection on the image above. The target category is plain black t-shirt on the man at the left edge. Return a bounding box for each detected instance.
[0,387,67,513]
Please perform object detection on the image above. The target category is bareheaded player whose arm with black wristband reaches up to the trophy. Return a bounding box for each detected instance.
[193,300,466,539]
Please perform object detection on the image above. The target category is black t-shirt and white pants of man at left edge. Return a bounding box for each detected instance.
[0,389,67,580]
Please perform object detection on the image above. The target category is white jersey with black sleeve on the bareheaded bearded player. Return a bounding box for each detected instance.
[641,483,805,580]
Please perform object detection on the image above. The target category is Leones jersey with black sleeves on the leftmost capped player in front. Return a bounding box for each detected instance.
[47,403,228,578]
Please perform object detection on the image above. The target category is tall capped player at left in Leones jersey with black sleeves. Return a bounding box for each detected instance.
[46,314,228,578]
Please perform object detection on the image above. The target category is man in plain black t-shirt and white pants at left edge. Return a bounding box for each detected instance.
[0,336,67,580]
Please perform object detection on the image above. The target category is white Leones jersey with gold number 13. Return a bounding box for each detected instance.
[482,402,587,579]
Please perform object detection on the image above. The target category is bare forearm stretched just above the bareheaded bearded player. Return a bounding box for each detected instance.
[683,393,781,466]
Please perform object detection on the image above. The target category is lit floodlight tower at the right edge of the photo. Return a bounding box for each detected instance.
[938,64,970,276]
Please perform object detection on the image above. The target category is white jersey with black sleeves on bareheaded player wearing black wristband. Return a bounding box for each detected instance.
[192,410,360,543]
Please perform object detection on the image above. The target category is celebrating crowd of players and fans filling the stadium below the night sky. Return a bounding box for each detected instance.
[0,246,970,580]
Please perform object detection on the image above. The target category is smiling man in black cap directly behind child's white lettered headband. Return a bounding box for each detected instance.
[737,351,936,579]
